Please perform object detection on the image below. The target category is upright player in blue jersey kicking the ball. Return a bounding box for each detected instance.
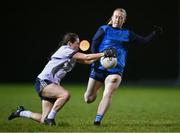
[84,8,162,125]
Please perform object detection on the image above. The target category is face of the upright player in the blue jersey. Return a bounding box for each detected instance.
[112,10,126,28]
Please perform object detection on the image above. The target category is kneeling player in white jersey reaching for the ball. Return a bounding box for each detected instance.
[8,33,112,125]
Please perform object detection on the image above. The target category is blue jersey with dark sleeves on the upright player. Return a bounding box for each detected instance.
[91,25,155,73]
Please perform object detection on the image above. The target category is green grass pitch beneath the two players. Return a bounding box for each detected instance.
[0,84,180,132]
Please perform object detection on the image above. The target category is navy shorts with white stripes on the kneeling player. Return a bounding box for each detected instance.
[35,78,56,103]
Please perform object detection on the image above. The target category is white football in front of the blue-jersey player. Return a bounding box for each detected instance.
[100,57,117,69]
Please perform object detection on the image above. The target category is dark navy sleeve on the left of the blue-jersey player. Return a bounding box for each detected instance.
[91,27,105,53]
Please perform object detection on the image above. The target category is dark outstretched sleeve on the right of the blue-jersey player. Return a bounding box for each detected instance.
[129,31,156,44]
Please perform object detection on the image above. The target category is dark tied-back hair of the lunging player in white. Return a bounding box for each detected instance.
[59,32,79,45]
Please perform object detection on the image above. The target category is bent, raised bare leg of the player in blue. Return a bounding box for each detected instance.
[84,78,103,103]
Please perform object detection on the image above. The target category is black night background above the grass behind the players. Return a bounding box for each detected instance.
[3,0,180,83]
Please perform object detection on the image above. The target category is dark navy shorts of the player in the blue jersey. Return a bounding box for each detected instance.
[90,68,122,82]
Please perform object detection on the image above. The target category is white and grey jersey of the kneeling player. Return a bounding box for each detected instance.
[38,45,76,84]
